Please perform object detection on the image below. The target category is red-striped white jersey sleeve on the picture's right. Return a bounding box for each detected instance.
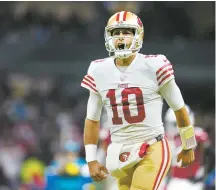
[152,55,175,88]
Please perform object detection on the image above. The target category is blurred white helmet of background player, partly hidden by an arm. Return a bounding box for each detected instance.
[164,105,195,135]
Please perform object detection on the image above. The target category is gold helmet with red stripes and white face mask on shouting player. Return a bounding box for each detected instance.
[104,11,144,59]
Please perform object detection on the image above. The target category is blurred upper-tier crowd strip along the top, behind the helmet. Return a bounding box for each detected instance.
[0,1,214,44]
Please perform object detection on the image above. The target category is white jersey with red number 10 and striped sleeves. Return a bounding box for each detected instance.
[81,53,174,144]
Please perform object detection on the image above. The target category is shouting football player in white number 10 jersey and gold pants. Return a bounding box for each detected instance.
[81,11,196,190]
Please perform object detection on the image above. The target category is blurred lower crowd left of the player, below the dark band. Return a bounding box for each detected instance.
[0,72,87,190]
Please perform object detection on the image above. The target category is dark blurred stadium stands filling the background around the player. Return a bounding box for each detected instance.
[0,2,215,190]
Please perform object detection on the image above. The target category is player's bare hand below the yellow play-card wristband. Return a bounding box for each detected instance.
[177,149,195,167]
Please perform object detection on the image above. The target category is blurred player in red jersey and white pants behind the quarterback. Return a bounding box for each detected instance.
[161,105,209,190]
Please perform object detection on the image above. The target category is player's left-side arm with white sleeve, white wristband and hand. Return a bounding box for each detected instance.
[84,92,108,181]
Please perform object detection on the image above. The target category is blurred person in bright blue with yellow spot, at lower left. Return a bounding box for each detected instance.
[45,140,95,190]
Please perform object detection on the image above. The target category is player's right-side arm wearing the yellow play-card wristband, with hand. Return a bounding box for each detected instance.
[160,79,196,166]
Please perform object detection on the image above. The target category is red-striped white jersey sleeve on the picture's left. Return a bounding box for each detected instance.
[81,62,99,94]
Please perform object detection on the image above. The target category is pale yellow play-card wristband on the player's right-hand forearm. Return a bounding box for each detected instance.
[179,125,197,150]
